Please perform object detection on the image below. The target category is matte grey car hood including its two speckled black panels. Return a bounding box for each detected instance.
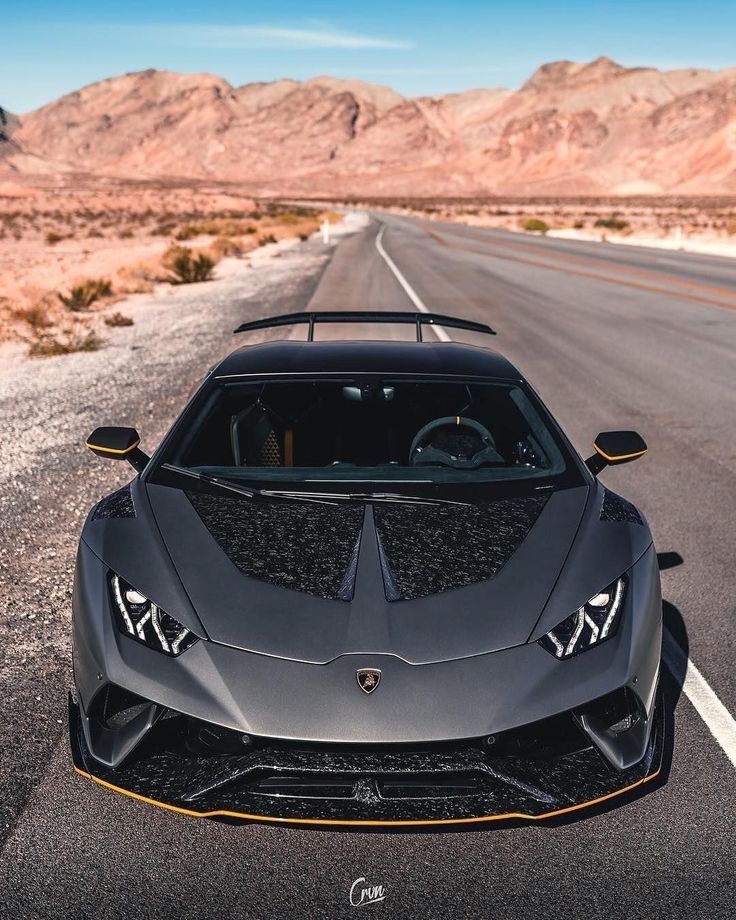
[138,485,589,664]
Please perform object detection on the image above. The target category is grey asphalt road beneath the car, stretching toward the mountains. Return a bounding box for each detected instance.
[0,217,736,918]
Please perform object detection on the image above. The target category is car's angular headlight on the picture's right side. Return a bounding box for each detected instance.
[539,575,626,658]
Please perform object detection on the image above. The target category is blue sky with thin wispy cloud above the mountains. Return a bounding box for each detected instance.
[0,0,736,113]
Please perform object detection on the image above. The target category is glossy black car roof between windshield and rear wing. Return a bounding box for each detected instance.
[212,341,523,380]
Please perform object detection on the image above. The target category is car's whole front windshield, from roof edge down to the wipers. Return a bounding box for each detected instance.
[153,376,577,493]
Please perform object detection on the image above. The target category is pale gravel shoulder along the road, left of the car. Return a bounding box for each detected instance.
[0,215,361,842]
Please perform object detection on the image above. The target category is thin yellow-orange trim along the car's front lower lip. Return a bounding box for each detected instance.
[74,766,661,827]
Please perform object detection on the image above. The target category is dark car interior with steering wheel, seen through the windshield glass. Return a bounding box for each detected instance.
[172,377,559,470]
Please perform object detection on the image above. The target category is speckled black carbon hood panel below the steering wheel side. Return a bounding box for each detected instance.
[374,495,548,601]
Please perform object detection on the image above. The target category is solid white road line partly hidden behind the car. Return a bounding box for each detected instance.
[376,224,736,767]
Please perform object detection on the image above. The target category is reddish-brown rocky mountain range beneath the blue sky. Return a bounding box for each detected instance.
[6,58,736,196]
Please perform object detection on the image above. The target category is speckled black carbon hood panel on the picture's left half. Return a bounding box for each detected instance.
[187,492,363,600]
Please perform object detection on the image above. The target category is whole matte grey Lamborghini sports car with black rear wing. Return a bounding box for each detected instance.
[70,312,664,825]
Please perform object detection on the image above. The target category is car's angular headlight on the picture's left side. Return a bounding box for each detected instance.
[110,574,197,656]
